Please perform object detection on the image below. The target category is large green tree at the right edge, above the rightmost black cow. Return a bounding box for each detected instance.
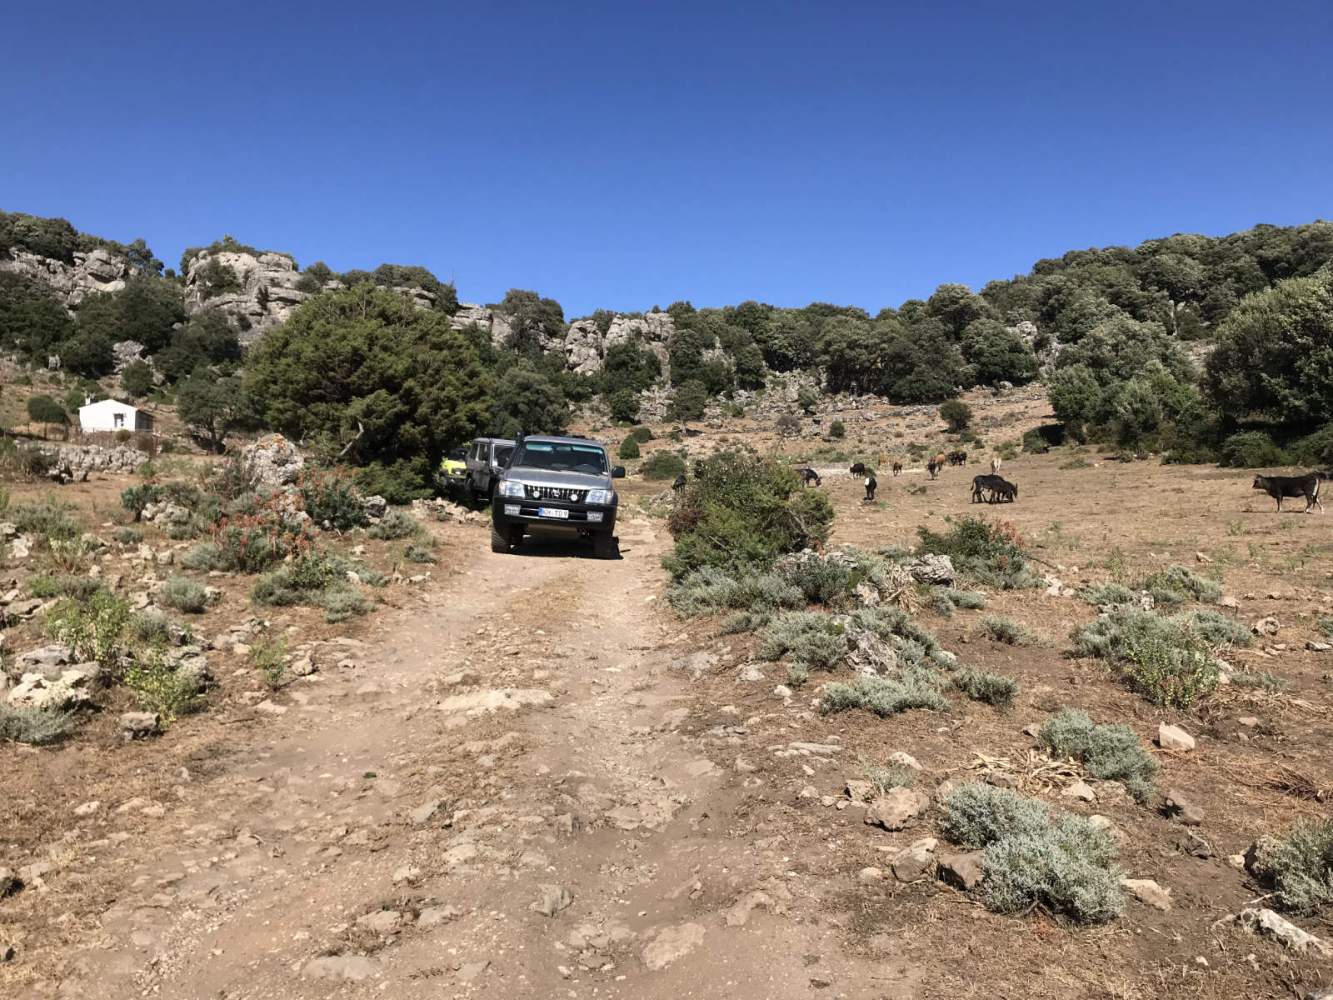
[1204,271,1333,431]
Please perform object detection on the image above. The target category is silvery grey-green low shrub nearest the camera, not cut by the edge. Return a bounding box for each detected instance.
[941,783,1124,924]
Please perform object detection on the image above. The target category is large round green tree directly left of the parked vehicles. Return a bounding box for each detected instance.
[245,284,493,500]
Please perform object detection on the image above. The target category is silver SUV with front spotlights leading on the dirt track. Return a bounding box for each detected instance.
[491,437,625,559]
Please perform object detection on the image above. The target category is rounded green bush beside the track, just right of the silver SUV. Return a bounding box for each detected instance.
[664,452,833,579]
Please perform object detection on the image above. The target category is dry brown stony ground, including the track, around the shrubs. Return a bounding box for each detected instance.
[0,395,1333,1000]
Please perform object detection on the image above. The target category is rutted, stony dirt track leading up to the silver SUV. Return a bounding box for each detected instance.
[33,520,913,1000]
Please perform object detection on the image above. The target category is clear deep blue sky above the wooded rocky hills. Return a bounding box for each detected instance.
[0,0,1333,316]
